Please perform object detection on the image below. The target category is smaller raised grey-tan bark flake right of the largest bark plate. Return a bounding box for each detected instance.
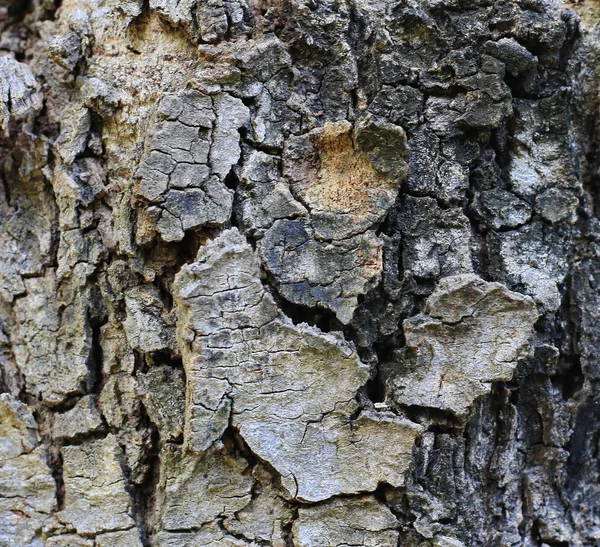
[388,274,537,416]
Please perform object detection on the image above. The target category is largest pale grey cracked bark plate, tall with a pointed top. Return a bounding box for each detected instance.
[175,229,421,502]
